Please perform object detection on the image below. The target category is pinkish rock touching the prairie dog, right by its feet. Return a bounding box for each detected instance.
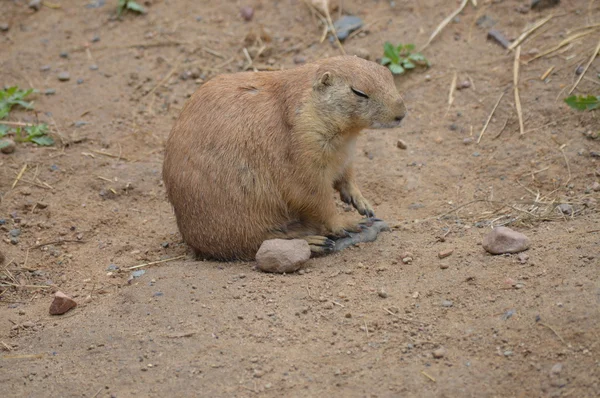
[256,239,310,274]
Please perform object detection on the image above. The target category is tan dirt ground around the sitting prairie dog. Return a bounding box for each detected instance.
[0,0,600,397]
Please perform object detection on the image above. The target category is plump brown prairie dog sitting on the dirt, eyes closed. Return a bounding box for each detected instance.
[163,56,406,260]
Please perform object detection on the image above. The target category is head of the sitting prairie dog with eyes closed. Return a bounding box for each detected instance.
[313,56,406,131]
